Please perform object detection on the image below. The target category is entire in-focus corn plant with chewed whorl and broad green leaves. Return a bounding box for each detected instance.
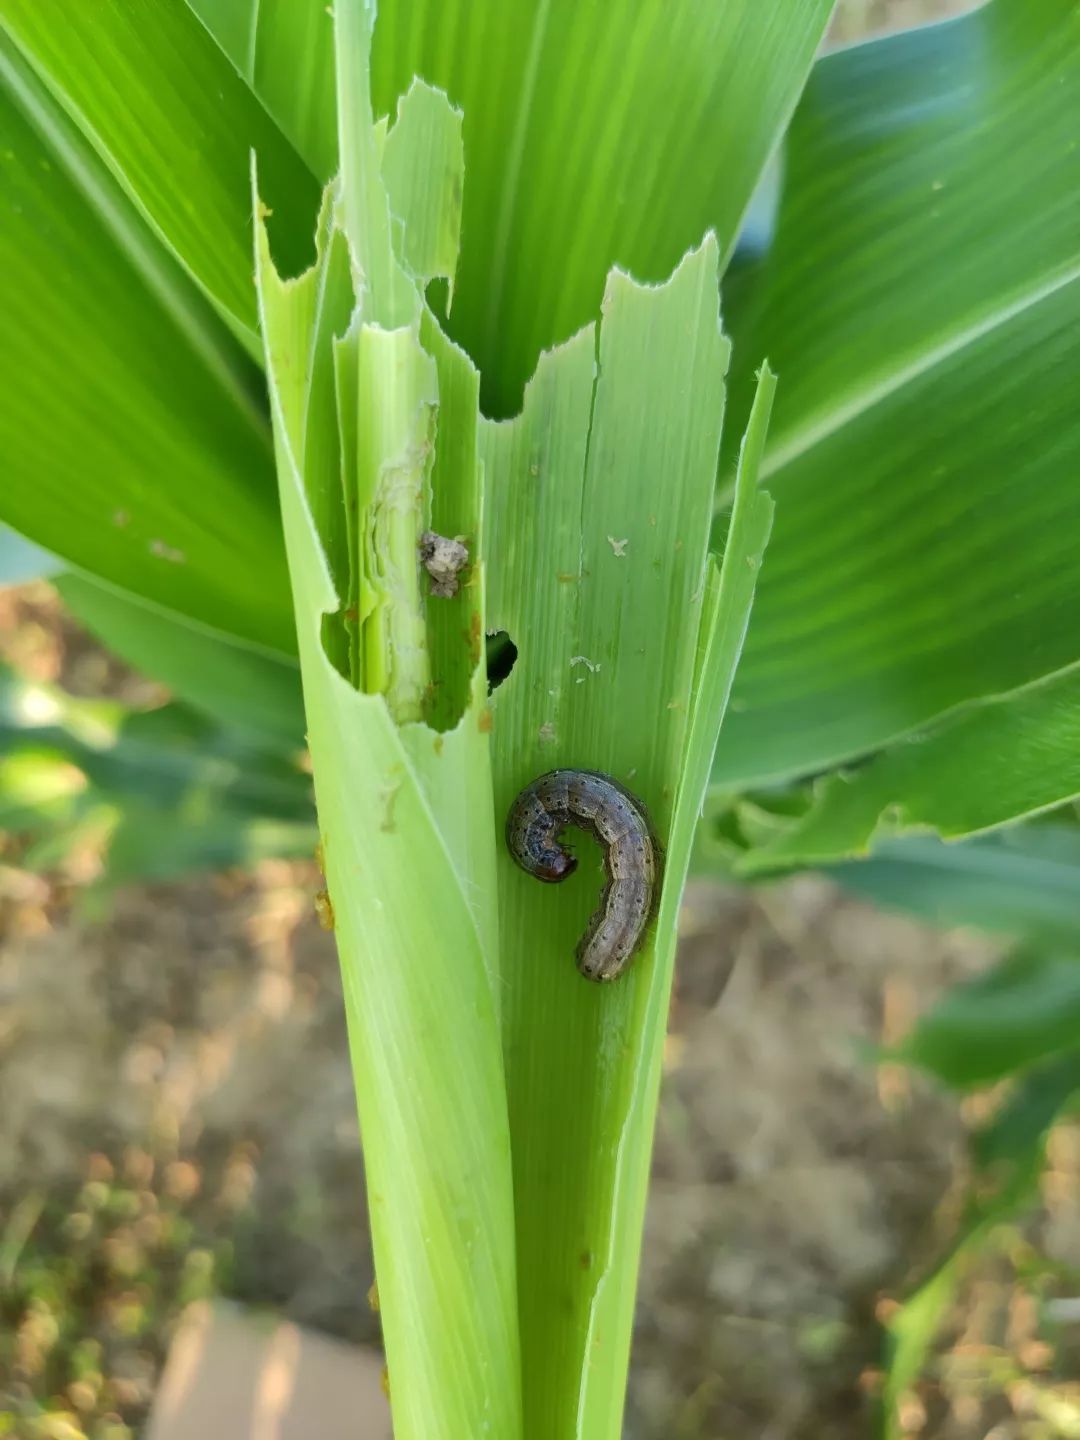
[0,0,1080,1440]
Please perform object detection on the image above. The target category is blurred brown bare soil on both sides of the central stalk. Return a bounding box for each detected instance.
[0,823,982,1440]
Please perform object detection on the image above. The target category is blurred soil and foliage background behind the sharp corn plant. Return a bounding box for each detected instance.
[0,0,1080,1440]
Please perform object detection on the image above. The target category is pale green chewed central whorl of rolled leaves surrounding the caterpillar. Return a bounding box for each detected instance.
[259,4,772,1436]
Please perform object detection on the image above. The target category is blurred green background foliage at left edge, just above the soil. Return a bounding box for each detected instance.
[0,667,317,886]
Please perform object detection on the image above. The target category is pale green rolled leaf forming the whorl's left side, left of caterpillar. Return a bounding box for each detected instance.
[258,6,521,1440]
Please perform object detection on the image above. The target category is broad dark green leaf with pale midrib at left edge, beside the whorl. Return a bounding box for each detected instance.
[0,35,294,652]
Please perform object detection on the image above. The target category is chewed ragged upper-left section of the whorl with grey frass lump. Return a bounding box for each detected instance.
[259,70,482,732]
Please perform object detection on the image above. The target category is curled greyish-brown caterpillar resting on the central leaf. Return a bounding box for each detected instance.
[507,770,664,981]
